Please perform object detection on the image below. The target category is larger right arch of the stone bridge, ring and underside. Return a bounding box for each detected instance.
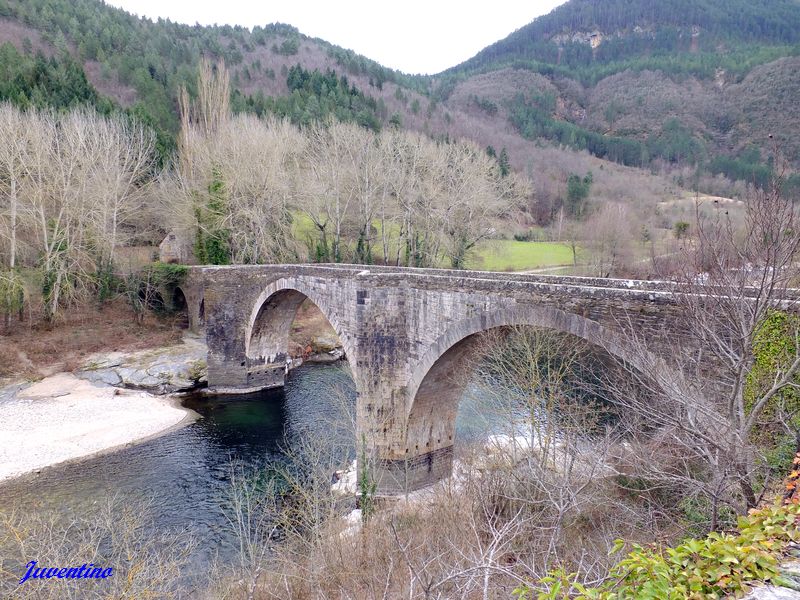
[403,306,663,489]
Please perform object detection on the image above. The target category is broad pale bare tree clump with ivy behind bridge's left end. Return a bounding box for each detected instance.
[175,95,306,263]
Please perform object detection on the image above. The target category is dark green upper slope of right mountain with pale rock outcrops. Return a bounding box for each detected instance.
[450,0,800,72]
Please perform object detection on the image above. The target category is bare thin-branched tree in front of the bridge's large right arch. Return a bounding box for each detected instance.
[466,327,643,580]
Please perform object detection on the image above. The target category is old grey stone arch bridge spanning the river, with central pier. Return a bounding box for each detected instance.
[182,265,679,494]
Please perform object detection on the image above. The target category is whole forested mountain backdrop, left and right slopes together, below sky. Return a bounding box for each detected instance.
[0,0,800,264]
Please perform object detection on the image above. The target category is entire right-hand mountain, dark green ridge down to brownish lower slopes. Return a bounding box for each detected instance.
[435,0,800,193]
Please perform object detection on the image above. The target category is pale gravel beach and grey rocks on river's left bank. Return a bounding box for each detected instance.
[0,334,343,481]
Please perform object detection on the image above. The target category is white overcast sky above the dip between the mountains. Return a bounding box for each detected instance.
[106,0,564,73]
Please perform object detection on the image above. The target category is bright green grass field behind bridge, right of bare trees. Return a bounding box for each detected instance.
[467,240,572,271]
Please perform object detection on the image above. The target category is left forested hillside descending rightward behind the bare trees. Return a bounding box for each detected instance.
[0,0,681,235]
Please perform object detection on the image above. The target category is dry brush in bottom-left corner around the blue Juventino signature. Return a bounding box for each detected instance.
[0,497,197,600]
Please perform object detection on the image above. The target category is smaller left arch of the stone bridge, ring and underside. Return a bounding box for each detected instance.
[245,278,353,366]
